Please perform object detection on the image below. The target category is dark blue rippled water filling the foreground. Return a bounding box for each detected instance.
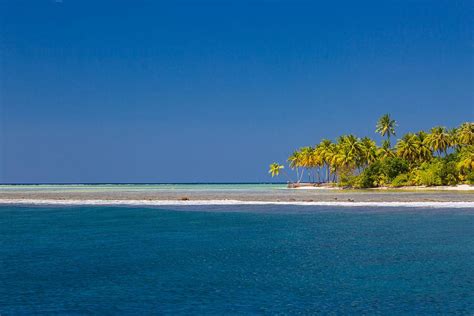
[0,206,474,315]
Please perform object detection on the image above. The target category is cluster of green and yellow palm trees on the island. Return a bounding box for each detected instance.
[269,114,474,189]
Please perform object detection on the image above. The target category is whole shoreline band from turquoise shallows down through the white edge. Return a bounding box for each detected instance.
[0,184,474,207]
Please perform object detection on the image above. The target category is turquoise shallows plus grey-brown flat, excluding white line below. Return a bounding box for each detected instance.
[0,183,474,202]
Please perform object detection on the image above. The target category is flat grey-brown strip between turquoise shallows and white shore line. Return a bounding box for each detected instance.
[0,188,474,203]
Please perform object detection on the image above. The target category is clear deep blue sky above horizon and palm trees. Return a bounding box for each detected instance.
[0,0,474,183]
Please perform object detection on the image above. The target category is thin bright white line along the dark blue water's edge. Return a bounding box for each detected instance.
[0,199,474,208]
